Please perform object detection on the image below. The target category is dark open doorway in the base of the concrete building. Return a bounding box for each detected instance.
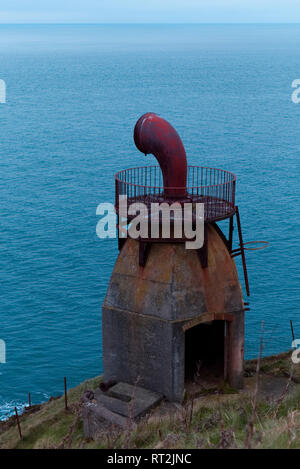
[185,321,227,384]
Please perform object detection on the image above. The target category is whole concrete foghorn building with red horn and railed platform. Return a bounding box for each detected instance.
[102,113,249,402]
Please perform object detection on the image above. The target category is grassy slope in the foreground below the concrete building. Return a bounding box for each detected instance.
[0,354,300,449]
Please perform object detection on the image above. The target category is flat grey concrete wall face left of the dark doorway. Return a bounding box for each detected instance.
[102,308,184,395]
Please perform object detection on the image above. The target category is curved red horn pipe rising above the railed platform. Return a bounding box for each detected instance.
[134,112,187,198]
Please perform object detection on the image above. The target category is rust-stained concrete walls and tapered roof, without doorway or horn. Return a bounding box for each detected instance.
[103,225,244,401]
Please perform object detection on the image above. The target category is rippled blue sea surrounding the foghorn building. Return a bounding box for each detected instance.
[0,24,300,418]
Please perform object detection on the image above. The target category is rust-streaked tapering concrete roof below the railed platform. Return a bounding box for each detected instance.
[103,225,244,321]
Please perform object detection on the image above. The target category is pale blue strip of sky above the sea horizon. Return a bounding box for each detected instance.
[0,0,300,23]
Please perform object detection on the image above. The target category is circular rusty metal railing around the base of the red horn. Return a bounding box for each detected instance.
[115,166,236,222]
